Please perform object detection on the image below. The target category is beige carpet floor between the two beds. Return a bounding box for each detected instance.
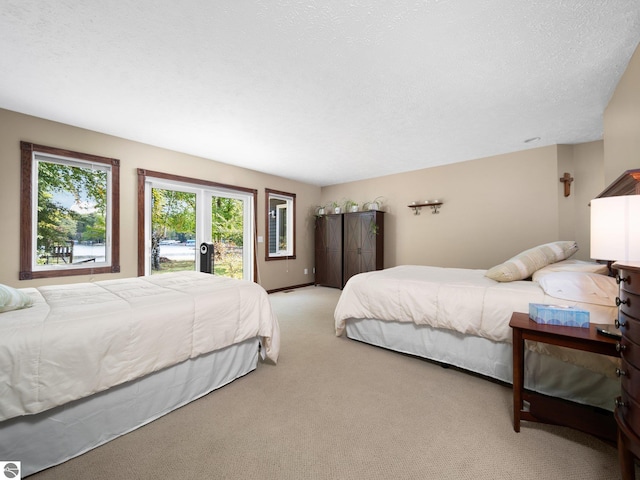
[29,287,620,480]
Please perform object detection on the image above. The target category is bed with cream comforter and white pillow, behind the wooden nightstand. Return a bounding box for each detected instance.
[335,261,619,410]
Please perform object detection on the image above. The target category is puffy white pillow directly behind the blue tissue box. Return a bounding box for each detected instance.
[540,272,618,307]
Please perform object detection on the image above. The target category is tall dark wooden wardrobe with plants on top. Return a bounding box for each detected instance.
[315,210,384,288]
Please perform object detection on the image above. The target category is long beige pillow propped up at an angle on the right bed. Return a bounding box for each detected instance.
[485,241,578,282]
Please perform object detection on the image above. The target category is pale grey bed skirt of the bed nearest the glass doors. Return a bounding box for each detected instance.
[0,338,259,477]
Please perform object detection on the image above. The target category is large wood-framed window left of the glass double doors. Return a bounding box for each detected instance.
[19,142,120,280]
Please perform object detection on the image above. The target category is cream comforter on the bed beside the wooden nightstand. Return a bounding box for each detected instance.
[335,265,616,342]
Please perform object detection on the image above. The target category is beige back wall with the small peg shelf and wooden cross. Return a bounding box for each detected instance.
[322,142,602,268]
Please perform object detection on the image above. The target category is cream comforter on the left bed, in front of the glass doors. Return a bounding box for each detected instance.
[0,272,280,420]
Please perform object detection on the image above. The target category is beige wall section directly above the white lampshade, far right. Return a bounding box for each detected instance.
[604,46,640,186]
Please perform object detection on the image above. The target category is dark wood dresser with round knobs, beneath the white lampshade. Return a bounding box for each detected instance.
[614,264,640,480]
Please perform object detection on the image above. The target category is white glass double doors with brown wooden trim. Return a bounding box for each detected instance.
[138,169,257,281]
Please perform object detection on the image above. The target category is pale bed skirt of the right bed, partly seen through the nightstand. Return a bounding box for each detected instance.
[346,319,620,411]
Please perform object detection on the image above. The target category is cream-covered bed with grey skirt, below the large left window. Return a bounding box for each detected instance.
[0,272,280,474]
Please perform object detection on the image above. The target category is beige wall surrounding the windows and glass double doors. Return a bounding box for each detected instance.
[0,109,320,290]
